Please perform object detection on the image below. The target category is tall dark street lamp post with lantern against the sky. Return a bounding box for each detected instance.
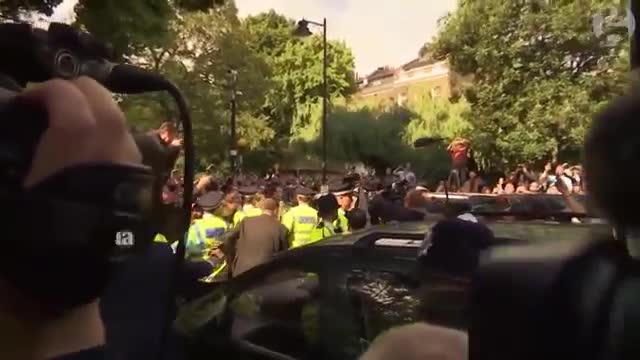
[294,18,329,185]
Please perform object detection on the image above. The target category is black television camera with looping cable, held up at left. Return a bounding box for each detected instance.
[0,23,194,356]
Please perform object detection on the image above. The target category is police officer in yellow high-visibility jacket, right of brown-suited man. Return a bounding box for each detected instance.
[282,186,318,248]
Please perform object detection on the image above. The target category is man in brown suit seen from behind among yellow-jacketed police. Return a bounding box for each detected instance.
[224,198,289,277]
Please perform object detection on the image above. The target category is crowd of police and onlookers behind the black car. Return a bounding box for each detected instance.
[138,120,583,358]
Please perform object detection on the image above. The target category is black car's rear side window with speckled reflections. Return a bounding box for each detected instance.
[347,270,467,342]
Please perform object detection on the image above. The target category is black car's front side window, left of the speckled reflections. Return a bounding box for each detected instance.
[230,268,321,359]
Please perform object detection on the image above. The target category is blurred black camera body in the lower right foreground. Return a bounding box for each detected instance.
[470,239,640,360]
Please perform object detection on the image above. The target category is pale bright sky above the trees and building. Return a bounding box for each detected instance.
[52,0,457,75]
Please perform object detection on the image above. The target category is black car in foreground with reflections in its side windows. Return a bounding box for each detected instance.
[176,222,608,360]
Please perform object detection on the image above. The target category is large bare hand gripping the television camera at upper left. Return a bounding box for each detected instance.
[21,77,142,187]
